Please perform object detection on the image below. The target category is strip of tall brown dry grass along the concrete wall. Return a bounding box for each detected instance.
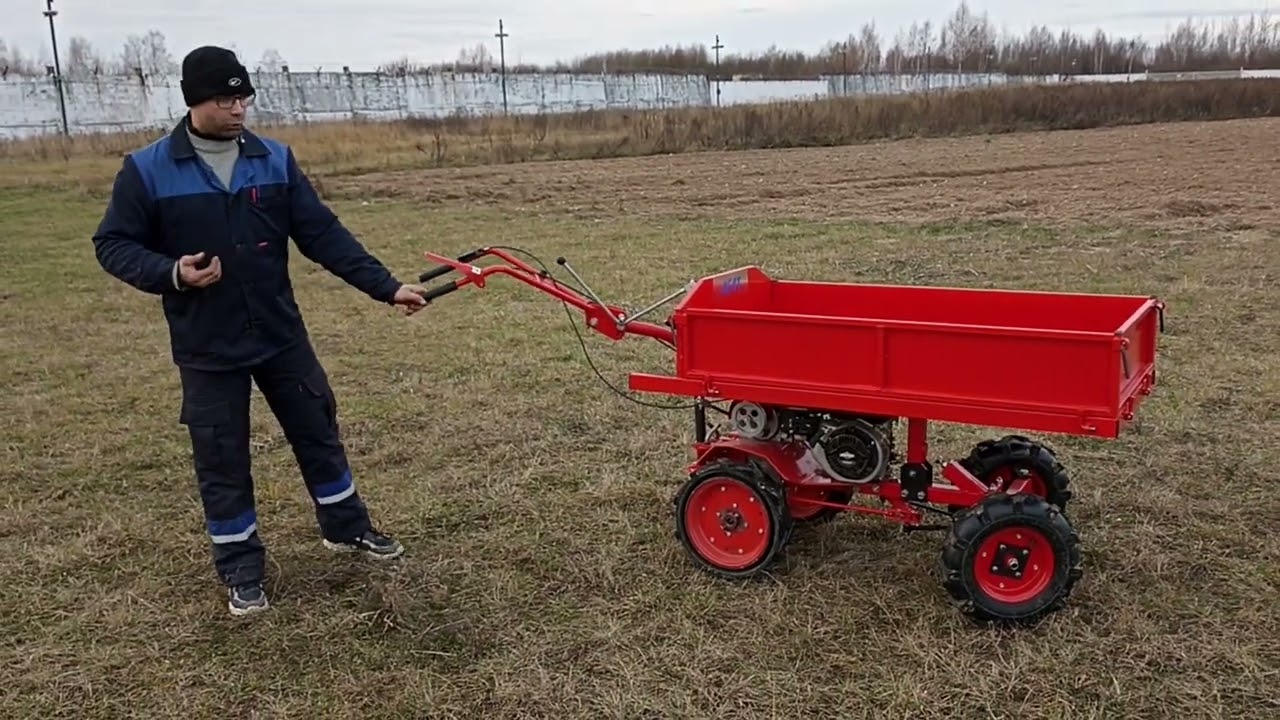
[0,78,1280,188]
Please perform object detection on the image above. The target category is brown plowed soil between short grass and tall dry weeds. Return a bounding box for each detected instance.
[326,119,1280,231]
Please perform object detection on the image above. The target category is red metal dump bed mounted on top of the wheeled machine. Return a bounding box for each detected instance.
[631,266,1162,437]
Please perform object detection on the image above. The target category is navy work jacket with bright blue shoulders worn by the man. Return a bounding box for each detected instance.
[93,118,401,370]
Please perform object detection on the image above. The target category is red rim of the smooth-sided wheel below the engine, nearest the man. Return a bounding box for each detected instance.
[685,478,773,570]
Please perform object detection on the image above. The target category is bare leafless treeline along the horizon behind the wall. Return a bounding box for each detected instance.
[0,3,1280,79]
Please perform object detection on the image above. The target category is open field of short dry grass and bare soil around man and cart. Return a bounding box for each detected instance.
[0,89,1280,720]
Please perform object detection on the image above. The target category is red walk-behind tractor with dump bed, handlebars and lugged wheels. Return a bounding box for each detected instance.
[420,247,1164,621]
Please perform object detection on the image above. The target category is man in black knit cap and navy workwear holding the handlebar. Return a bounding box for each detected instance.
[93,46,426,615]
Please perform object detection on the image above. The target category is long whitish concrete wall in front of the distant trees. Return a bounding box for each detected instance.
[0,70,1280,138]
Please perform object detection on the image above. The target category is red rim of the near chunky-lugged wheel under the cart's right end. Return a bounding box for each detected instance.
[973,527,1057,605]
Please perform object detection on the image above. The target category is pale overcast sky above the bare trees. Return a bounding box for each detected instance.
[0,0,1280,70]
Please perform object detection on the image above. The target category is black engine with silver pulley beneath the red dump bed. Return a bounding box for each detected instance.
[728,401,895,483]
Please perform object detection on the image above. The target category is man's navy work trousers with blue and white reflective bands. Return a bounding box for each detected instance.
[179,340,370,587]
